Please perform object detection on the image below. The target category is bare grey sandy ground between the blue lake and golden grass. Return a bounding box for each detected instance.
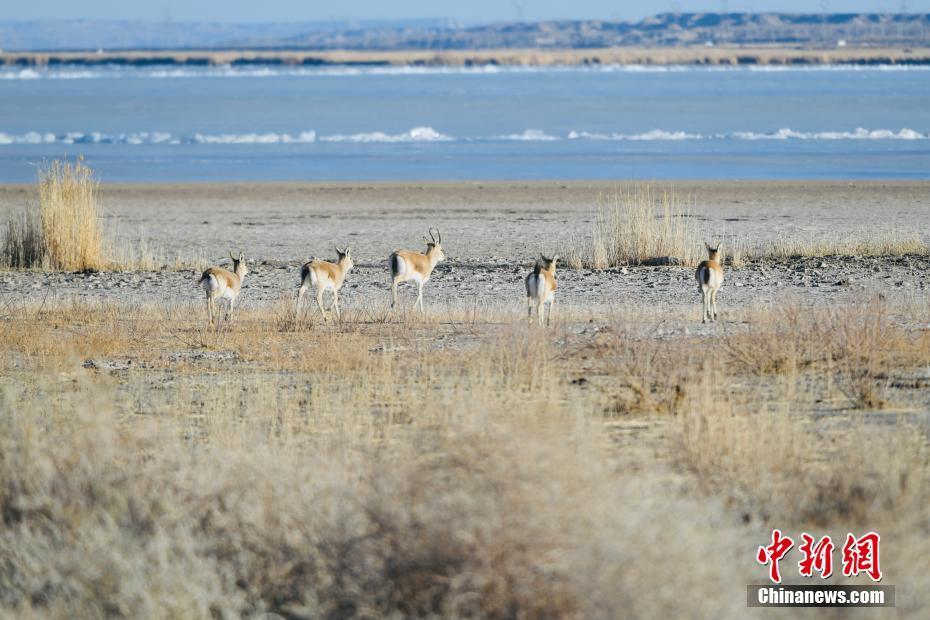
[0,181,930,313]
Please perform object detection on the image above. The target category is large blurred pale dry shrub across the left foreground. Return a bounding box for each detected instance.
[0,370,747,618]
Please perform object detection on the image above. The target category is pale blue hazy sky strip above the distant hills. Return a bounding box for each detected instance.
[0,0,930,22]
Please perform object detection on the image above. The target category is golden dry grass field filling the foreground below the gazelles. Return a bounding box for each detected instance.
[0,171,930,618]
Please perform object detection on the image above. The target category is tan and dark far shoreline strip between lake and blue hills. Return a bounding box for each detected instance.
[0,46,930,68]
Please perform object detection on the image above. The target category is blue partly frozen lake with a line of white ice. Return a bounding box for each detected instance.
[0,67,930,182]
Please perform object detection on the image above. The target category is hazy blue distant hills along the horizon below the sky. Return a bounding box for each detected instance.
[0,13,930,51]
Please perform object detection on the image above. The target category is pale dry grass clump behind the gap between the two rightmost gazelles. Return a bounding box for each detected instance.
[566,185,702,269]
